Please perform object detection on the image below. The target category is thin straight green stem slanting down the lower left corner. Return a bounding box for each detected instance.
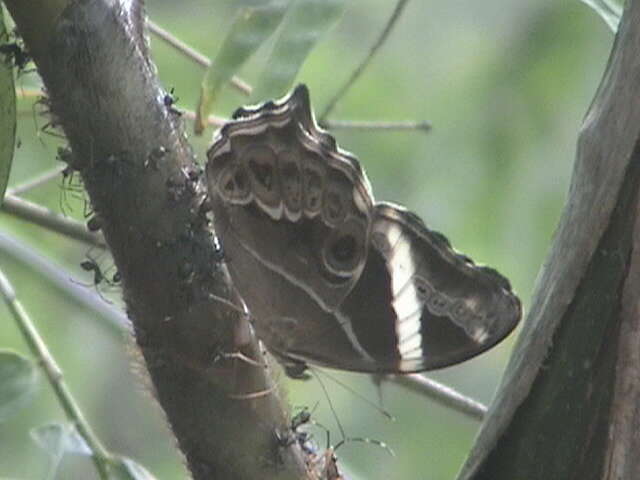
[0,269,111,480]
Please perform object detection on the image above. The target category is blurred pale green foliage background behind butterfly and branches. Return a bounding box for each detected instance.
[0,0,613,480]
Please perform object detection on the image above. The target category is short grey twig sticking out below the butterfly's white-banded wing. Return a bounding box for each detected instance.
[388,374,487,420]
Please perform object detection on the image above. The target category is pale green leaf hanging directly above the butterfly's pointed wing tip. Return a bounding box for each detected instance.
[252,0,345,101]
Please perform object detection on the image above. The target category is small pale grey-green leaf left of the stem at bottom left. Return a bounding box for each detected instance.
[30,422,92,478]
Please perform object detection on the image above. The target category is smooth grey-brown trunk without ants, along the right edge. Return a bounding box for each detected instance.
[459,0,640,480]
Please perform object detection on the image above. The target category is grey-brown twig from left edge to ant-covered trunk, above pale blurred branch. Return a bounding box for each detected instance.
[0,195,106,248]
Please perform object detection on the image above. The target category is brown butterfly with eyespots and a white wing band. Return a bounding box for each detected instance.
[206,85,522,375]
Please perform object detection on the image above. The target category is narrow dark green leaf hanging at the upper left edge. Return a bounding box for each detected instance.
[0,9,16,204]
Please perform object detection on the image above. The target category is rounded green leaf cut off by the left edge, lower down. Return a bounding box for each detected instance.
[0,350,38,421]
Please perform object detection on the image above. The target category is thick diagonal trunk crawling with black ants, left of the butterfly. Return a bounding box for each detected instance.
[5,0,310,480]
